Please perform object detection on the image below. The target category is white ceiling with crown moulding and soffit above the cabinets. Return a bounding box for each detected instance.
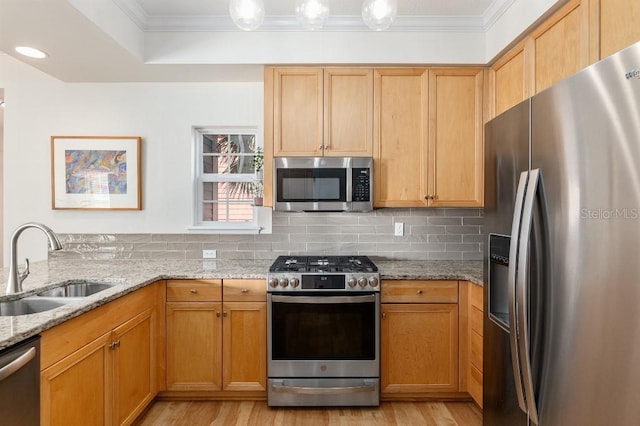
[0,0,544,82]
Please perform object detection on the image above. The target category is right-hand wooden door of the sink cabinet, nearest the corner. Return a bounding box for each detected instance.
[112,309,156,425]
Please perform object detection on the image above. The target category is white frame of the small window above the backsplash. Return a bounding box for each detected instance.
[188,126,262,234]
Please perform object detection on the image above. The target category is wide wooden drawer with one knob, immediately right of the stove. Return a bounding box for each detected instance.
[380,280,458,303]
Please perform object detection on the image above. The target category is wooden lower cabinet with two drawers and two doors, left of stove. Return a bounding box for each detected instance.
[167,280,267,396]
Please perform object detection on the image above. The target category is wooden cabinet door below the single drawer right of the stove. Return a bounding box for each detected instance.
[380,304,458,393]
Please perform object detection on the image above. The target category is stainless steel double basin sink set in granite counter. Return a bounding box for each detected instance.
[0,280,118,316]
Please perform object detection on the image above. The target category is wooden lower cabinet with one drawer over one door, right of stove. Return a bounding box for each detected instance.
[380,280,458,398]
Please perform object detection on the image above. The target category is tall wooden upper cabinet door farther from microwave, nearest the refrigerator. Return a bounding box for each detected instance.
[427,68,484,207]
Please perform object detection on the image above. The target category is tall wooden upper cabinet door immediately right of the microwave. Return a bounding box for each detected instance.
[373,68,429,207]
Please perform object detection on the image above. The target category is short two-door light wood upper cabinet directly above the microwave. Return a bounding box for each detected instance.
[265,67,373,157]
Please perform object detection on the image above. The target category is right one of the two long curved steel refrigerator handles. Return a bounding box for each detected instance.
[516,169,540,425]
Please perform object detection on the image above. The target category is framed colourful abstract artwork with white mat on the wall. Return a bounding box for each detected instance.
[51,136,142,210]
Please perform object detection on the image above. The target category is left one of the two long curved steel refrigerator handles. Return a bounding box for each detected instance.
[507,172,529,413]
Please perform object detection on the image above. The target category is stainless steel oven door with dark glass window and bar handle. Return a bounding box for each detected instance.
[267,292,380,378]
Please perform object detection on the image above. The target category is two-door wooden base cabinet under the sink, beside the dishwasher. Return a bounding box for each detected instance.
[40,283,164,426]
